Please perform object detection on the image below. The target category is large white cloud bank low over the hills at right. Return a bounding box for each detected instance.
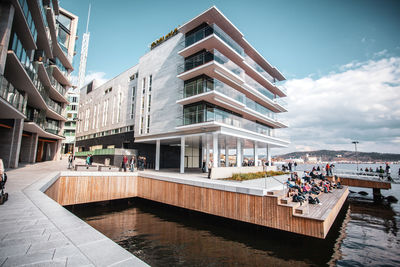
[273,57,400,154]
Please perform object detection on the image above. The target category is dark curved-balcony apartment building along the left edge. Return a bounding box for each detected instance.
[0,0,78,167]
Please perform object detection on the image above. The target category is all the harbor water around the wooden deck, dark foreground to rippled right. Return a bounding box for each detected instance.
[69,164,400,266]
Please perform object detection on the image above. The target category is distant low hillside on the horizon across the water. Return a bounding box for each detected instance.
[275,150,400,162]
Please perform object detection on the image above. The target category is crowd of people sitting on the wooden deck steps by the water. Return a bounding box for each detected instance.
[286,170,343,205]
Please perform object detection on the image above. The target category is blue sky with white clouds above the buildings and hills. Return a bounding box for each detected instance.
[60,0,400,154]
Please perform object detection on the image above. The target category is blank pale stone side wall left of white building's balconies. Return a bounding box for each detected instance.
[135,33,184,136]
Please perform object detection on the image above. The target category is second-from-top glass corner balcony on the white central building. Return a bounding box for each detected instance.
[177,49,244,84]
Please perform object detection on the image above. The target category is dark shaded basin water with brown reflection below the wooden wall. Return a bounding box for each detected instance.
[67,199,347,266]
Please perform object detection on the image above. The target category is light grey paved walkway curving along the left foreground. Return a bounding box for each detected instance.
[0,159,147,267]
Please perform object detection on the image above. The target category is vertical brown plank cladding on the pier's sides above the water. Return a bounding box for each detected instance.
[45,176,348,241]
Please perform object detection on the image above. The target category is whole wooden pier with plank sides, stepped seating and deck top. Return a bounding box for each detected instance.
[45,172,349,238]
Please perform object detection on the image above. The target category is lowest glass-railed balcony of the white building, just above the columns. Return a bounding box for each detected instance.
[177,107,288,144]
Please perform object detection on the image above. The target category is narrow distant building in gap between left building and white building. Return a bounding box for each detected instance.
[62,89,79,154]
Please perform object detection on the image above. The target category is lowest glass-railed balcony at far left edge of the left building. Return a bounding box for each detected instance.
[0,75,27,119]
